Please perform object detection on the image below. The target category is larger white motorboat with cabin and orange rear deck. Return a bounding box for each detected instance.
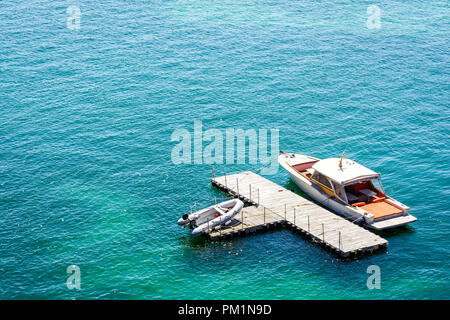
[278,152,417,230]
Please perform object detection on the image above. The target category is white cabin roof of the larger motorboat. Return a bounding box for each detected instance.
[312,158,380,185]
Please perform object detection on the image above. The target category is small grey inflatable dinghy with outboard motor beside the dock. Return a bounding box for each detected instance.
[178,199,244,236]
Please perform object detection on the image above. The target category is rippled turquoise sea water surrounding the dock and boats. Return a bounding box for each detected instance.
[0,0,450,299]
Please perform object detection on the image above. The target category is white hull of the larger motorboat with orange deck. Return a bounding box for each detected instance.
[278,154,416,230]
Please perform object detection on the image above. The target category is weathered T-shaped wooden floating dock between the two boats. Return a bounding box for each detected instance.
[209,171,388,257]
